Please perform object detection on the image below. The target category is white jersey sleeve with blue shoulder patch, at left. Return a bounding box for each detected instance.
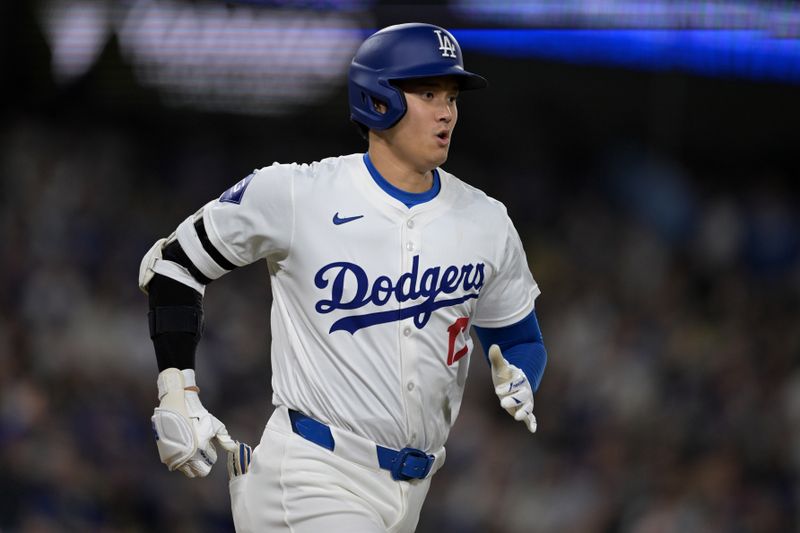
[195,164,294,267]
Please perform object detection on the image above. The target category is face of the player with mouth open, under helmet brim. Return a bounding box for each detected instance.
[386,77,458,171]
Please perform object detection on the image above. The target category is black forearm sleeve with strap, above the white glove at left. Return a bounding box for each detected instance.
[147,274,203,371]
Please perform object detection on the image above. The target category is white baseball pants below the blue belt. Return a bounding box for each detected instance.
[230,406,444,533]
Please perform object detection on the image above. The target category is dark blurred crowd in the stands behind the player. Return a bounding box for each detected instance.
[0,105,800,533]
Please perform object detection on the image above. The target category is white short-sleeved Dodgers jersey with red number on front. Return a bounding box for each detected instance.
[171,154,539,450]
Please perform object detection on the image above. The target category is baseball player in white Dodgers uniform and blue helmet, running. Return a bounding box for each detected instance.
[139,23,546,533]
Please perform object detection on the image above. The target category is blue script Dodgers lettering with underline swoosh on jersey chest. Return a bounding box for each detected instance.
[314,255,484,334]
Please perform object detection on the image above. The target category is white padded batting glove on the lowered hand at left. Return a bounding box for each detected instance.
[151,368,237,477]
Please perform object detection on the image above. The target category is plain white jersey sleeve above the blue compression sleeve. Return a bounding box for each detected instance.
[472,212,540,328]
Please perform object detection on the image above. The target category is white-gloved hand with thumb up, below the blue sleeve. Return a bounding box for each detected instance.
[489,344,536,433]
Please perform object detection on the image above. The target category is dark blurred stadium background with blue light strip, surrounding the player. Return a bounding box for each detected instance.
[0,0,800,533]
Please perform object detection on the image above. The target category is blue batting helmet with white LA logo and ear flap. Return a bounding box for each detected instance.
[348,23,487,130]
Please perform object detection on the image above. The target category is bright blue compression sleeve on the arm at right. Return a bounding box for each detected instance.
[475,310,547,392]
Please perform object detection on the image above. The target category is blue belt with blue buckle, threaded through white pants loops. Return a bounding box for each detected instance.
[289,409,436,481]
